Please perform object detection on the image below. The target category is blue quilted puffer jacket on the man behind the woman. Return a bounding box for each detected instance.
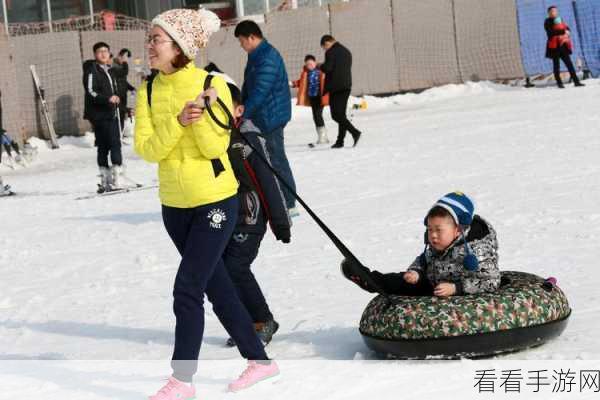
[242,40,292,133]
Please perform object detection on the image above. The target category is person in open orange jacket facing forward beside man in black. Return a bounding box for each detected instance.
[290,54,329,147]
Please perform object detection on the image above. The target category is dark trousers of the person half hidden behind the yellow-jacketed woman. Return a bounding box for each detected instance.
[223,232,273,322]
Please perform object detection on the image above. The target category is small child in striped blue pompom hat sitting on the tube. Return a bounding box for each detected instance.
[342,192,500,297]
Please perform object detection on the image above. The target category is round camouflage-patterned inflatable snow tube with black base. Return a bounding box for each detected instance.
[360,272,571,359]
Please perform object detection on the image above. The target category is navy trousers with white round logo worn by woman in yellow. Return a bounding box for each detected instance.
[162,196,267,382]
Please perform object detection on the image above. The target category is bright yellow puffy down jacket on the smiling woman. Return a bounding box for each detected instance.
[135,62,238,208]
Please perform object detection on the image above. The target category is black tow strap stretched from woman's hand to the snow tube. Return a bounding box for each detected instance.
[204,96,387,297]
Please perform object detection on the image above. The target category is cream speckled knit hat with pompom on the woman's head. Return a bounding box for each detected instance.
[152,8,221,60]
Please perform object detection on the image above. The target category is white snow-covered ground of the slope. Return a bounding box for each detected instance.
[0,81,600,399]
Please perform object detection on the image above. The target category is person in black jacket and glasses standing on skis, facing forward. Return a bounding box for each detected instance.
[83,42,123,192]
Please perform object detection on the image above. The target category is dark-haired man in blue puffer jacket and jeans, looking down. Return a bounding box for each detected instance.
[234,21,298,216]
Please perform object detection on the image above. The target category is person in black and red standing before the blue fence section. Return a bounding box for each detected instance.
[544,6,585,89]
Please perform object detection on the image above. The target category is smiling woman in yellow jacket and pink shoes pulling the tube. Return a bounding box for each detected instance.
[135,9,279,400]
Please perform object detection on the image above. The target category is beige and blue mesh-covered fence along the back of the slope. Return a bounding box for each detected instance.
[0,0,600,143]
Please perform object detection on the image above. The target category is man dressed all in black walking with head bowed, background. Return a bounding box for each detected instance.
[320,35,361,149]
